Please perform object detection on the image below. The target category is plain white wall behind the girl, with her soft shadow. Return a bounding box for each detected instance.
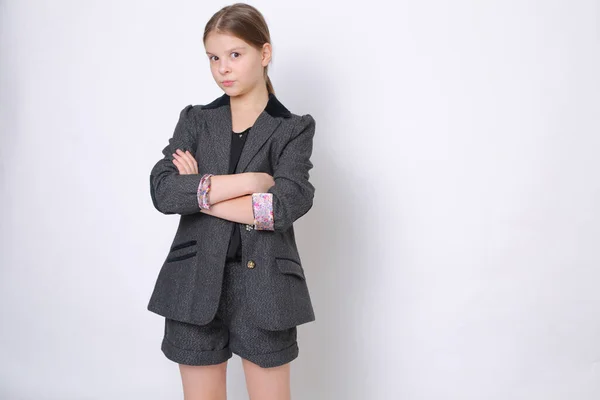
[0,0,600,400]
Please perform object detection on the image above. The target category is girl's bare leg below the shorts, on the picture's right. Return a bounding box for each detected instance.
[242,358,292,400]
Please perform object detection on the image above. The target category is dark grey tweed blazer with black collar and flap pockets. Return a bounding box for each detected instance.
[148,93,315,330]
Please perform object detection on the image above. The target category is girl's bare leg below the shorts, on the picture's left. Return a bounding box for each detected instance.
[179,361,227,400]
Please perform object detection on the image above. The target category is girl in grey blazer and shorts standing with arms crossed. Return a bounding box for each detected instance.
[148,3,315,400]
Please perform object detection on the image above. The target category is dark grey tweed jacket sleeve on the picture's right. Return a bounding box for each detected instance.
[262,114,316,231]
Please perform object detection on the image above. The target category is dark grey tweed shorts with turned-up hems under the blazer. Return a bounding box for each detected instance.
[161,261,298,368]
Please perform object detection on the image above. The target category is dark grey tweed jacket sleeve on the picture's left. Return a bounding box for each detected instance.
[150,105,202,215]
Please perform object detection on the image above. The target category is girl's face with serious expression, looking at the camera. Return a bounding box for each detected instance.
[204,32,271,96]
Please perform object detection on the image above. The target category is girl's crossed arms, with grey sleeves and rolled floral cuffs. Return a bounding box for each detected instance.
[149,105,315,231]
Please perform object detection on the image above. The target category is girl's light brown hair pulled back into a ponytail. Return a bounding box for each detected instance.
[203,3,275,94]
